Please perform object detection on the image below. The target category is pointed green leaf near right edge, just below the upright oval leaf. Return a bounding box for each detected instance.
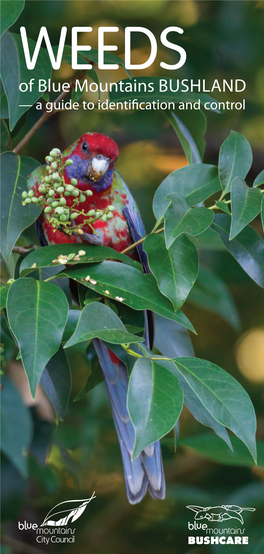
[229,177,262,240]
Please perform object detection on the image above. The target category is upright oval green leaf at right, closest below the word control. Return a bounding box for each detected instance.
[219,131,252,197]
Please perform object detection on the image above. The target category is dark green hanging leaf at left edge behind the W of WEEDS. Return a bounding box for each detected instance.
[1,31,51,131]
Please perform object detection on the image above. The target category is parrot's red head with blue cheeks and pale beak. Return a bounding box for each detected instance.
[63,133,119,191]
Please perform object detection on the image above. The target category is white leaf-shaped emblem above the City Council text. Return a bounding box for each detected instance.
[41,491,96,527]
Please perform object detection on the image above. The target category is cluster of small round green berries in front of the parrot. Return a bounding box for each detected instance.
[22,148,115,234]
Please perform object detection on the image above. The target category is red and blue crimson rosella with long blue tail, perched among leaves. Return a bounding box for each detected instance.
[29,133,165,504]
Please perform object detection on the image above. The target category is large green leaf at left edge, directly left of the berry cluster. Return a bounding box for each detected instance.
[1,152,40,261]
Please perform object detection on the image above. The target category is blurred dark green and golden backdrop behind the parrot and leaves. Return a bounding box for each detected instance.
[2,0,264,554]
